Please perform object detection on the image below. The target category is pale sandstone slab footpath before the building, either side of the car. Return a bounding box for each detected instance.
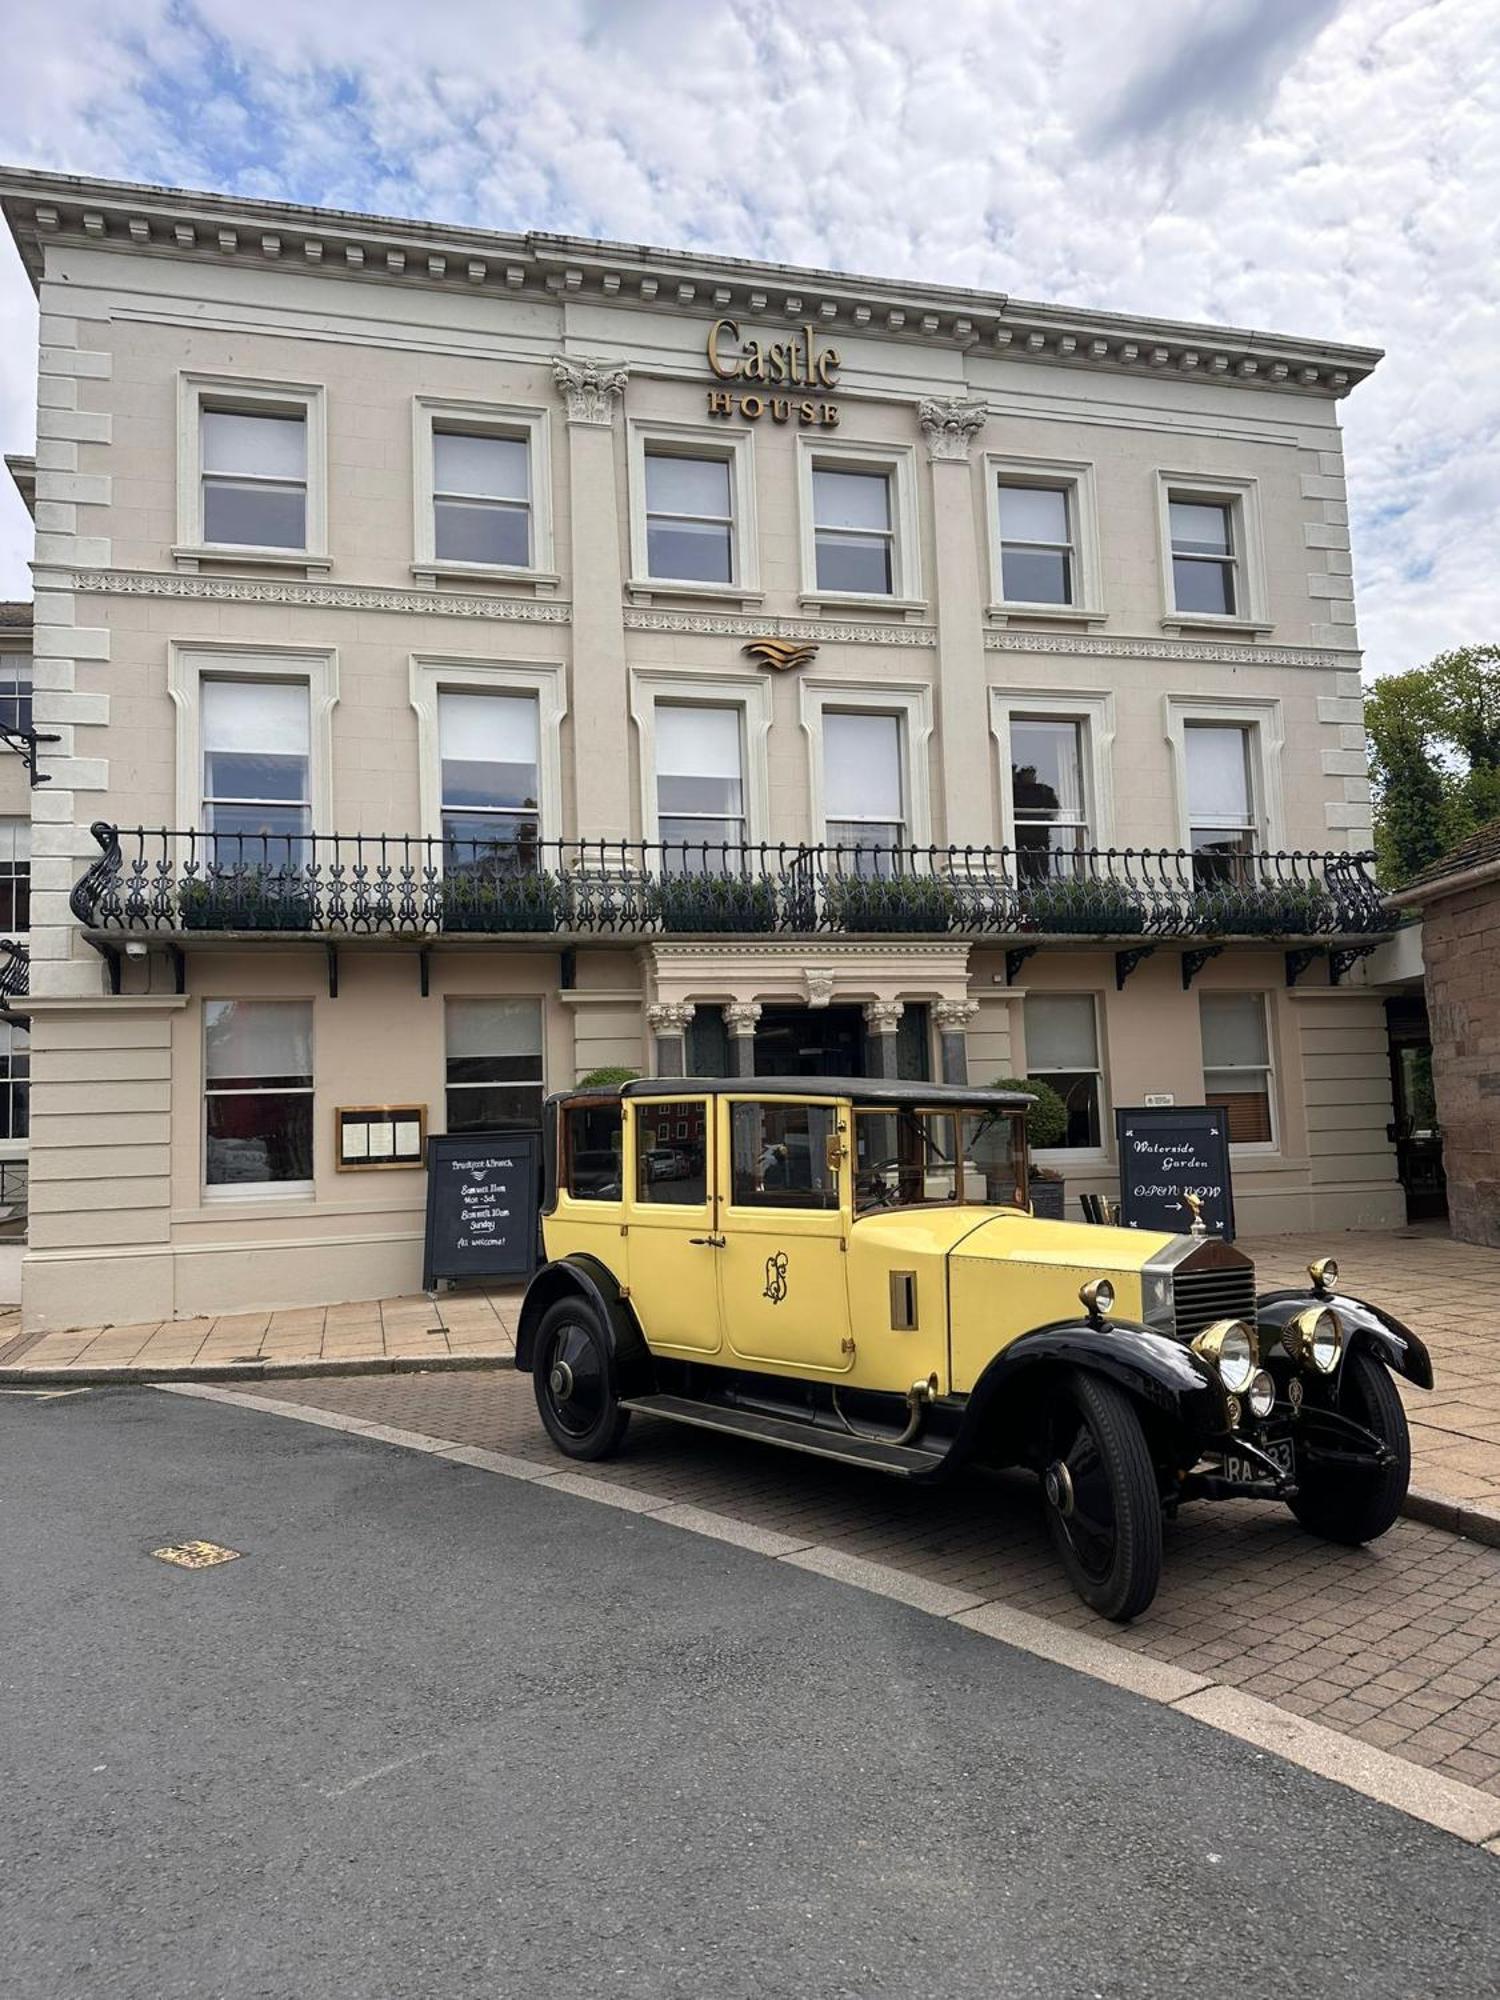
[0,1226,1500,1512]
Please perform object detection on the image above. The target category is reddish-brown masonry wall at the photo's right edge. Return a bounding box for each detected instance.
[1422,882,1500,1246]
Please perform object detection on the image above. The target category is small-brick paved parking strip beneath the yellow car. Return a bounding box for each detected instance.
[232,1370,1500,1796]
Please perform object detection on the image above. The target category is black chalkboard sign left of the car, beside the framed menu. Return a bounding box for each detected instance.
[422,1132,540,1292]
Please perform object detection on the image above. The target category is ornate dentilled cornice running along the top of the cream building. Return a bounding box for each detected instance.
[0,168,1380,396]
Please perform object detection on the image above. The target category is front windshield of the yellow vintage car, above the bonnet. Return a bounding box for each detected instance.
[854,1110,1026,1214]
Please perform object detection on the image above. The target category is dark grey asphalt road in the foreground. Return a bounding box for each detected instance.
[0,1390,1500,2000]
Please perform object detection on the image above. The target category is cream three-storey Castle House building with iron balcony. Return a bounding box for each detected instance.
[0,172,1402,1328]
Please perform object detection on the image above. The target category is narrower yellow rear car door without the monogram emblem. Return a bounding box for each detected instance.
[624,1090,720,1354]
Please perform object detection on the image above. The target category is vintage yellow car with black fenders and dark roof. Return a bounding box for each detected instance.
[516,1078,1432,1618]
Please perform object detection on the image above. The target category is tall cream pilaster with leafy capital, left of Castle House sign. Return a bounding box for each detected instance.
[552,356,636,844]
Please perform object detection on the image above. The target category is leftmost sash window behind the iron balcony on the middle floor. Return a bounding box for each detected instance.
[200,676,312,868]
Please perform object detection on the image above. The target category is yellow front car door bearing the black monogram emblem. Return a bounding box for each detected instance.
[716,1092,854,1374]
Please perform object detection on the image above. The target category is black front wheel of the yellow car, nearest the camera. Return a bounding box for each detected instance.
[1042,1372,1162,1620]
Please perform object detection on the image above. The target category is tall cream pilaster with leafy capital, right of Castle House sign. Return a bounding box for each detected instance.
[916,396,998,848]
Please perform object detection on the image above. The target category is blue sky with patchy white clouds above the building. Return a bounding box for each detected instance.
[0,0,1500,672]
